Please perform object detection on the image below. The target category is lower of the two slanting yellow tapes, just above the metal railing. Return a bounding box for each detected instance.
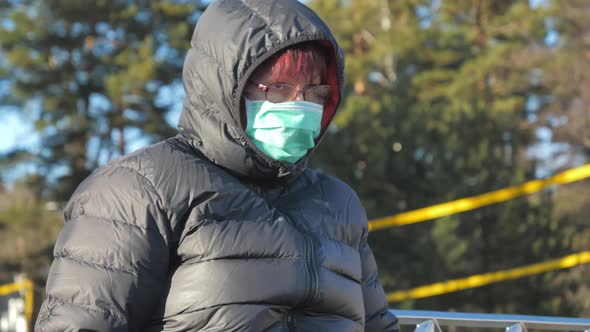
[387,251,590,302]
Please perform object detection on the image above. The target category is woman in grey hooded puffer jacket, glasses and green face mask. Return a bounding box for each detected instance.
[36,0,398,331]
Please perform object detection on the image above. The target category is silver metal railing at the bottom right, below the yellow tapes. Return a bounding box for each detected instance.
[391,310,590,332]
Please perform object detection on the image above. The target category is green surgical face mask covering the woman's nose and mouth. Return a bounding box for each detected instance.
[246,99,323,163]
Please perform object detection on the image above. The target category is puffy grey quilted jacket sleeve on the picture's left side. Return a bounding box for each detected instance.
[35,166,170,332]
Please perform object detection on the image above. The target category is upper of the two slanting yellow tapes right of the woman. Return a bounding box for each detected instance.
[369,164,590,231]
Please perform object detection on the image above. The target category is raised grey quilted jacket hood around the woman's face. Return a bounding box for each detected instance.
[179,0,344,183]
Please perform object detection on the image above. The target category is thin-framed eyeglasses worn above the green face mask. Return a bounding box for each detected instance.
[251,82,332,105]
